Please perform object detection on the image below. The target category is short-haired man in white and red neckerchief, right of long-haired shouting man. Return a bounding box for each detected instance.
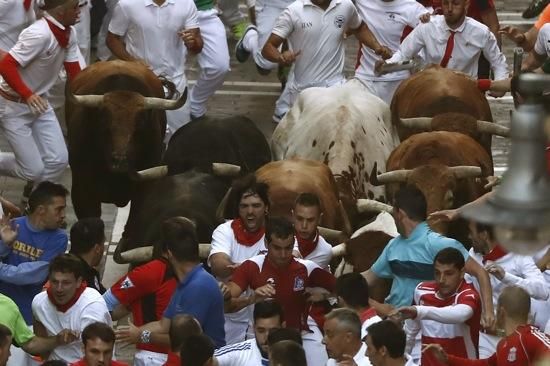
[292,193,332,271]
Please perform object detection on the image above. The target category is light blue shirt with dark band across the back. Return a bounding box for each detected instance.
[371,222,469,306]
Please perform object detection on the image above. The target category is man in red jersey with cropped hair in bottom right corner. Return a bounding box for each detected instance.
[430,286,550,366]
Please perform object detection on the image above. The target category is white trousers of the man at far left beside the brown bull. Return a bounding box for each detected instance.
[0,97,69,182]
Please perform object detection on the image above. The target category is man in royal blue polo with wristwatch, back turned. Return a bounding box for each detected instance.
[117,217,225,348]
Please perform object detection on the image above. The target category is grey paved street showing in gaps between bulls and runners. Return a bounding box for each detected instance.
[0,0,544,361]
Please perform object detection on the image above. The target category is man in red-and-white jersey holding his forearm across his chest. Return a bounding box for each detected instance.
[396,248,481,366]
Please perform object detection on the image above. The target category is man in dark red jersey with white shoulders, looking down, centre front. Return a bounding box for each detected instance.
[228,218,336,365]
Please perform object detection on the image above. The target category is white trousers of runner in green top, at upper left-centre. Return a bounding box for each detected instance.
[189,9,229,117]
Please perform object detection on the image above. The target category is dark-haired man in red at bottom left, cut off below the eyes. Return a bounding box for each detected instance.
[71,322,128,366]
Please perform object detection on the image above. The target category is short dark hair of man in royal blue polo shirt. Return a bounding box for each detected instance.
[160,216,200,262]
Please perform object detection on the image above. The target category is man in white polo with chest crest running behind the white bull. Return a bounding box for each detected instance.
[262,0,391,111]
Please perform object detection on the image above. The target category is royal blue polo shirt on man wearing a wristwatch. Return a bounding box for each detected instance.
[164,264,225,348]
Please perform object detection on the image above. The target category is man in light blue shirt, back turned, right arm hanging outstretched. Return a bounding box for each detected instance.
[363,186,494,327]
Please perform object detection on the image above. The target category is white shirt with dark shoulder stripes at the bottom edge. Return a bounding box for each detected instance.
[214,338,269,366]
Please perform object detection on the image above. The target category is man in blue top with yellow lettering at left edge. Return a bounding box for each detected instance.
[0,181,69,325]
